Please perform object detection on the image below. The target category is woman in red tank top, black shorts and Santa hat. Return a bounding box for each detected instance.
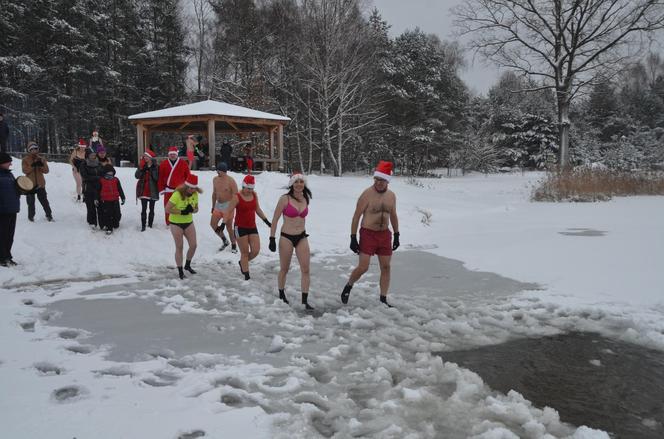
[228,175,272,280]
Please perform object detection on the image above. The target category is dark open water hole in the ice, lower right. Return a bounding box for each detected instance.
[441,332,664,439]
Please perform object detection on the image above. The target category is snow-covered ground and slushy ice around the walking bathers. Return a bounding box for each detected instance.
[0,161,664,439]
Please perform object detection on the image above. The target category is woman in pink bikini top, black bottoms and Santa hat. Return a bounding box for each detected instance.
[270,173,314,310]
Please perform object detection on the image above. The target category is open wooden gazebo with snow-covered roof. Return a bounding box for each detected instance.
[129,100,290,170]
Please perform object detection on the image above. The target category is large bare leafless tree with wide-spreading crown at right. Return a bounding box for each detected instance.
[454,0,664,166]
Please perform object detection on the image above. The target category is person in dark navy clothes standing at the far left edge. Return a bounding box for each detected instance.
[0,152,21,267]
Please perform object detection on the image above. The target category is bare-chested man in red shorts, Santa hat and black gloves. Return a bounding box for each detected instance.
[341,160,400,307]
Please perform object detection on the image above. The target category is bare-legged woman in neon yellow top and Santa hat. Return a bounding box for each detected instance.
[166,174,203,279]
